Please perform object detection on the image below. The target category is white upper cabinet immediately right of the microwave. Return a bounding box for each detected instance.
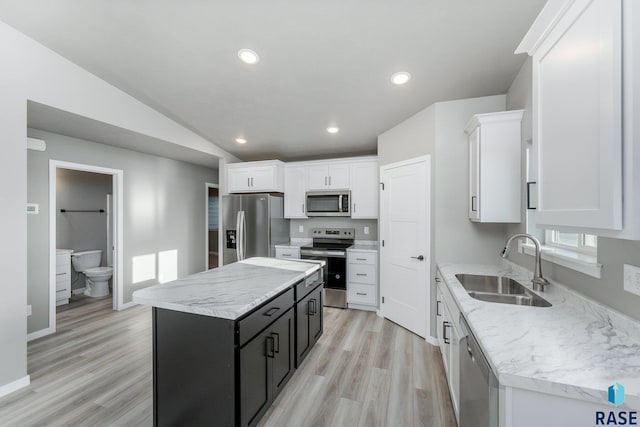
[350,159,380,219]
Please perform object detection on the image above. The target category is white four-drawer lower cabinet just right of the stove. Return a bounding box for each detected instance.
[347,249,378,311]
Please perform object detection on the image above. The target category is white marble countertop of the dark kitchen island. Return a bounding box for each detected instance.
[133,257,322,320]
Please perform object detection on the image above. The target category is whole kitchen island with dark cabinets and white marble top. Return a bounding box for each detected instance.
[133,258,323,426]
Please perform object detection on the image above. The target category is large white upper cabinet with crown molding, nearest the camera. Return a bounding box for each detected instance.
[517,0,638,237]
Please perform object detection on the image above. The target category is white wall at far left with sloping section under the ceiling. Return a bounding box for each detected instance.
[0,23,236,393]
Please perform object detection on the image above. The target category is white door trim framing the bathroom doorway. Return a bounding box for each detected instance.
[48,159,124,334]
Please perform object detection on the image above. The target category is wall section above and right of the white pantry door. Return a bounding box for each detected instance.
[378,95,506,336]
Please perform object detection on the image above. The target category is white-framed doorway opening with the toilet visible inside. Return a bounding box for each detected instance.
[48,160,124,333]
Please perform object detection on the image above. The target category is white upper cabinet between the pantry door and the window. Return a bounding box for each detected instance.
[465,110,524,223]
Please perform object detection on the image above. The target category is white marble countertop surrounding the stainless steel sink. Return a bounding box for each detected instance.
[438,262,640,409]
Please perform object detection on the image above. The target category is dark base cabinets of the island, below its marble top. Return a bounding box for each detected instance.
[153,274,322,426]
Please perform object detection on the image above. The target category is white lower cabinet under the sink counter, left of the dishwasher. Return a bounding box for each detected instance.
[436,272,462,420]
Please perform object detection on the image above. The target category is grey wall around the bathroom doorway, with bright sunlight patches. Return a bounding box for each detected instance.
[27,129,218,333]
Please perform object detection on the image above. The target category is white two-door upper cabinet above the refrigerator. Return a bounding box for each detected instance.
[227,160,284,193]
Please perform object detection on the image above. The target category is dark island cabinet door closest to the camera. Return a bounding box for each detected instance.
[240,330,274,426]
